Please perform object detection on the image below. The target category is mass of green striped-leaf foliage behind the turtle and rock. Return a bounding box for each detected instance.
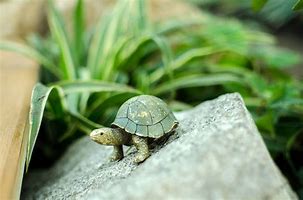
[0,0,303,195]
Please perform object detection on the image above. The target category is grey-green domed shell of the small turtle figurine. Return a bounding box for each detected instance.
[112,95,178,138]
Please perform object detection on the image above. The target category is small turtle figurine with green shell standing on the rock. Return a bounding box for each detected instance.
[90,95,178,163]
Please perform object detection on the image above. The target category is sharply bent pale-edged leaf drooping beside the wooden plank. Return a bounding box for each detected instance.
[26,83,67,170]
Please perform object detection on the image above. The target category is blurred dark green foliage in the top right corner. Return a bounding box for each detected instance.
[190,0,303,28]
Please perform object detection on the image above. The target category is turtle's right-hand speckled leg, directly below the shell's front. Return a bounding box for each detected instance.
[132,135,150,163]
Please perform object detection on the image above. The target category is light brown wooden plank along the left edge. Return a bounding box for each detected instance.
[0,51,38,199]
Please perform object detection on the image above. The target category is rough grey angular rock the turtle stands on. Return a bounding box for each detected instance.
[22,93,297,200]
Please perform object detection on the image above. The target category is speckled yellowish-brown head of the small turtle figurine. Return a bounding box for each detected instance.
[90,128,124,145]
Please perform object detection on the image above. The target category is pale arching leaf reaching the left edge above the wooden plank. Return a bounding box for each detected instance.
[0,41,62,78]
